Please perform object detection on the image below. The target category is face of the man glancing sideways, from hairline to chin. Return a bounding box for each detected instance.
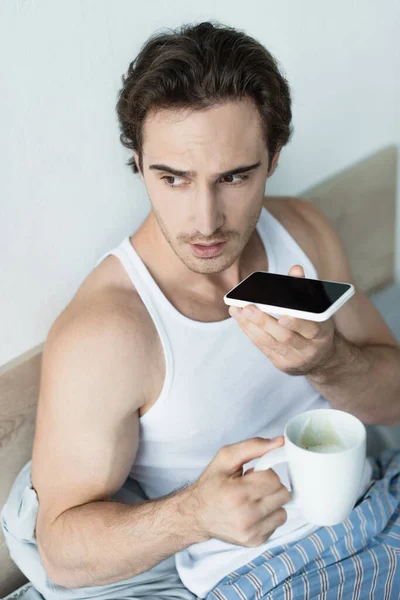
[136,99,275,274]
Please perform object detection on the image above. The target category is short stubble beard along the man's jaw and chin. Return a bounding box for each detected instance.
[153,204,262,275]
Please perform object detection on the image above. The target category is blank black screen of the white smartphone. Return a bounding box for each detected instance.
[227,271,350,313]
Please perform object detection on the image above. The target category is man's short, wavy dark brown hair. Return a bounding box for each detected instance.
[116,21,292,173]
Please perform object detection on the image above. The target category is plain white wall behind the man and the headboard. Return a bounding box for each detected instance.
[0,0,400,365]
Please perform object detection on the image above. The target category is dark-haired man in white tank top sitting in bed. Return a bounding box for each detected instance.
[2,18,400,599]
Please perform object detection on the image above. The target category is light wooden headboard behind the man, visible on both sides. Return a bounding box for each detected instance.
[0,146,397,597]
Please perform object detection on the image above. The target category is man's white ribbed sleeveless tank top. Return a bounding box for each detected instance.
[96,208,371,598]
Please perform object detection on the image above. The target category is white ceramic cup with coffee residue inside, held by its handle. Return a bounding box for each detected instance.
[254,409,366,526]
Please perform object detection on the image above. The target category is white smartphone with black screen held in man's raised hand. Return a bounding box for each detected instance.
[224,271,354,321]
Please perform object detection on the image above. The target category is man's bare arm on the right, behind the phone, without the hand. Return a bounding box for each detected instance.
[298,201,400,425]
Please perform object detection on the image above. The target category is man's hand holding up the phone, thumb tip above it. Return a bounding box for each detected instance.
[225,265,336,375]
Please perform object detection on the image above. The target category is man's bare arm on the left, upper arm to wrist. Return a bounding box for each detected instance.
[32,298,205,587]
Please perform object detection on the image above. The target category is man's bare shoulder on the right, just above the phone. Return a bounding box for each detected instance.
[264,196,351,281]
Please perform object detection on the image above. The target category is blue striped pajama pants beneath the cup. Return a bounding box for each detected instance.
[206,450,400,600]
